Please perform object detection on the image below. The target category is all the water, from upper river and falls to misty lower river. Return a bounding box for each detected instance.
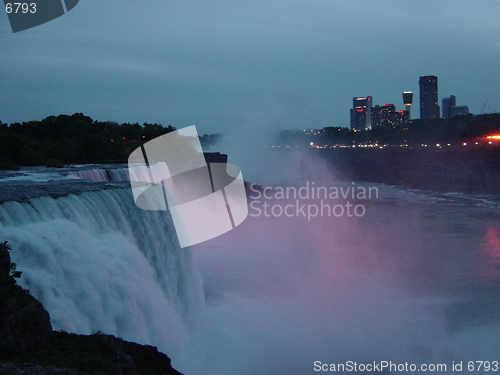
[0,165,500,375]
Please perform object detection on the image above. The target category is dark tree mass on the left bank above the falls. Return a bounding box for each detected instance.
[0,113,175,169]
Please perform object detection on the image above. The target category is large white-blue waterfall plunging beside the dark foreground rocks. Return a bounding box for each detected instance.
[0,188,203,354]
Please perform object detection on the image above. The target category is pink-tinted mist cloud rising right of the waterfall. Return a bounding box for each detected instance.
[180,148,500,375]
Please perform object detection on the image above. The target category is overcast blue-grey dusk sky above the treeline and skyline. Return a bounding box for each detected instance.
[0,0,500,134]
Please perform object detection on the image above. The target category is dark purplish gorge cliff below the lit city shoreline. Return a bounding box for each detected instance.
[312,145,500,196]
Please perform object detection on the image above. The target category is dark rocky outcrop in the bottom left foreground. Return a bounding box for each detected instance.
[0,242,182,375]
